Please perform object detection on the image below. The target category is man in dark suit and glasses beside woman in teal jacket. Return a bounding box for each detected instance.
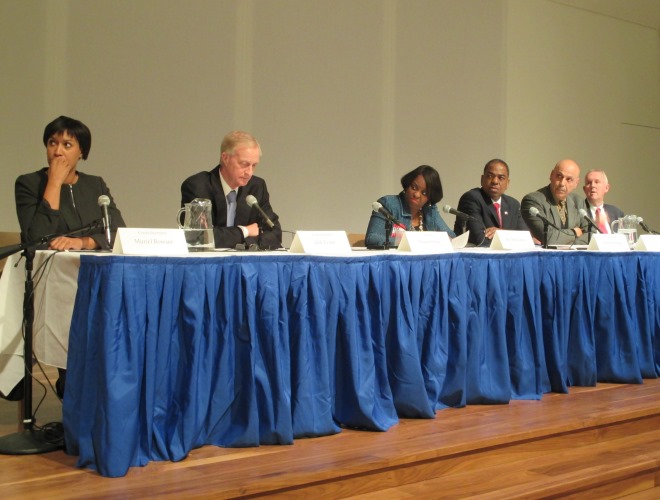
[454,159,527,246]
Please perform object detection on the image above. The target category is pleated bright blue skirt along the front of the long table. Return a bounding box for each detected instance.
[63,251,660,476]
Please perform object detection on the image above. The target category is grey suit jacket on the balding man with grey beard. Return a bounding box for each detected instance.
[520,186,589,245]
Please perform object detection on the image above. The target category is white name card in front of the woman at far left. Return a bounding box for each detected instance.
[112,227,188,255]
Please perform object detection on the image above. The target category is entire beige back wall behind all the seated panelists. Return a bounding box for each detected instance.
[0,0,660,238]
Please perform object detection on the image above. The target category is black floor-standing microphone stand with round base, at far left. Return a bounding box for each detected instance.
[0,219,101,455]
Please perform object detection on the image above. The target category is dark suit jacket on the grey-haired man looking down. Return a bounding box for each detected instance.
[181,165,282,249]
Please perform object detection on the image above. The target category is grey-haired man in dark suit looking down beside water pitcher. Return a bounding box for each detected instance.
[181,131,282,250]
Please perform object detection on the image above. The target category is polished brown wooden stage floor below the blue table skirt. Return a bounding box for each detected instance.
[0,366,660,500]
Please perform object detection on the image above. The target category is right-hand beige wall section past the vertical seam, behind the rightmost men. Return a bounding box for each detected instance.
[506,0,660,216]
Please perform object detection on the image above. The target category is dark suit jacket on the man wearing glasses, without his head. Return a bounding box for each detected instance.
[454,188,527,246]
